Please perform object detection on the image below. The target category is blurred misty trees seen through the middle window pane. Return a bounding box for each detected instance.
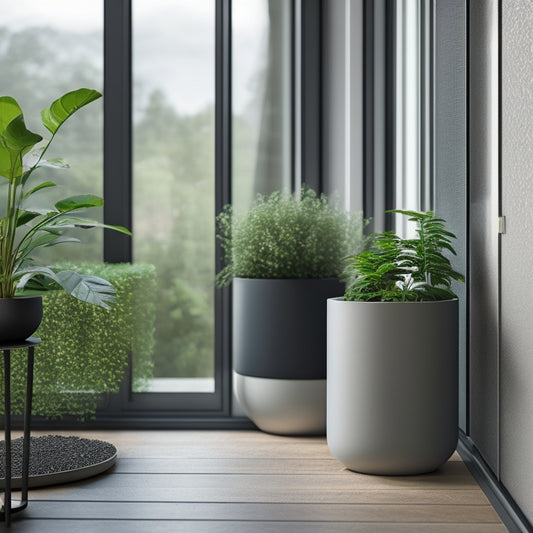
[133,92,215,378]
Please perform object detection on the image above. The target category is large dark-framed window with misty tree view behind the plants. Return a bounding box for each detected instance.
[0,0,320,427]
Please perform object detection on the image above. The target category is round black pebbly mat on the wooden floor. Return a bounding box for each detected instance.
[0,435,117,489]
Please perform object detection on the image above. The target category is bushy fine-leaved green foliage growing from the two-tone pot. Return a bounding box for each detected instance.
[217,188,363,286]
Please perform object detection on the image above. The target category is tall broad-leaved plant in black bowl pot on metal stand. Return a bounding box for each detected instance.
[0,88,129,343]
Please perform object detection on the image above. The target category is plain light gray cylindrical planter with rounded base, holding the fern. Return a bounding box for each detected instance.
[327,298,458,475]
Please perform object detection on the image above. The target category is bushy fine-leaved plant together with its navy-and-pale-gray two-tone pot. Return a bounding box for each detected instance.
[217,188,362,434]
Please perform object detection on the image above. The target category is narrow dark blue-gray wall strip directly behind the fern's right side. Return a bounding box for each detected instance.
[433,0,468,430]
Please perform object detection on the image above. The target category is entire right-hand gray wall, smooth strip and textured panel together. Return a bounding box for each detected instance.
[469,0,533,522]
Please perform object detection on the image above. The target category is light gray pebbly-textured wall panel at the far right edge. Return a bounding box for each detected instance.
[500,0,533,522]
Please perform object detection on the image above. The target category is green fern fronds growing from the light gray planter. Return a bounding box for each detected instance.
[344,210,464,302]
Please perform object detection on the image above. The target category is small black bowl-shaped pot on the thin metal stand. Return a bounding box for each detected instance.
[0,296,43,344]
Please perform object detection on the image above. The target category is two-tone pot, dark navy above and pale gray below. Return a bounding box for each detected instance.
[233,278,344,435]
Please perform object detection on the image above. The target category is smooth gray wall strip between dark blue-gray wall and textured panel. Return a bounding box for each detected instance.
[469,0,499,472]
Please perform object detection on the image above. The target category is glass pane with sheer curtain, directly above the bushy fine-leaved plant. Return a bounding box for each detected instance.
[232,0,292,210]
